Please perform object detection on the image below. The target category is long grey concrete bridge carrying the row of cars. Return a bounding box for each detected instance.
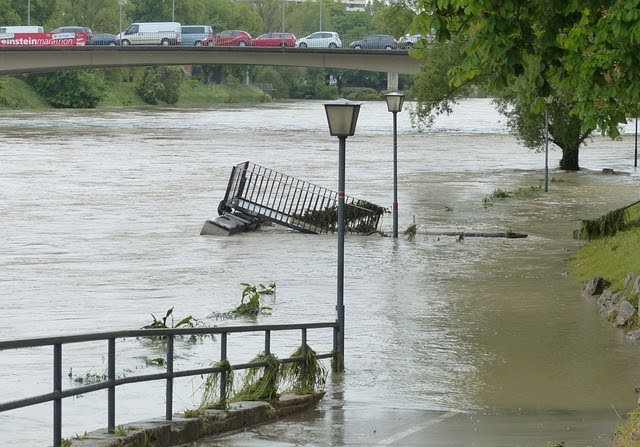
[0,46,421,90]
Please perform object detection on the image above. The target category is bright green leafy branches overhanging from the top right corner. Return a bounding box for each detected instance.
[418,0,640,136]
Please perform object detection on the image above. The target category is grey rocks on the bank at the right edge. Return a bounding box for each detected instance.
[582,273,640,341]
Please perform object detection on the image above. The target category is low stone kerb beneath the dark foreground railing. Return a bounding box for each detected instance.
[70,393,324,447]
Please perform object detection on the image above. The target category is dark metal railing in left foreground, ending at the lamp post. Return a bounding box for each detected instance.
[0,322,337,447]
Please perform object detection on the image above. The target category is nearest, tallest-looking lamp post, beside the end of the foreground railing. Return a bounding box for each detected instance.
[324,99,360,372]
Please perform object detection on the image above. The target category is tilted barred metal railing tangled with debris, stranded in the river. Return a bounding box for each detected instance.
[218,161,385,233]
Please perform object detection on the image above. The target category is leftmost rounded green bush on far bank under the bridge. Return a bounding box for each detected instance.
[27,70,105,108]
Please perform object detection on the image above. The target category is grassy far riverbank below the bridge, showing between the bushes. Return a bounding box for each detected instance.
[0,77,271,109]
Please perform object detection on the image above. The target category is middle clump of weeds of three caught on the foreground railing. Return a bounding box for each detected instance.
[231,354,282,403]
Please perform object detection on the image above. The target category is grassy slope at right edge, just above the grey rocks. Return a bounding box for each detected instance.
[570,228,640,291]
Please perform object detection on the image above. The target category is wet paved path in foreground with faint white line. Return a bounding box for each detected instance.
[178,390,620,447]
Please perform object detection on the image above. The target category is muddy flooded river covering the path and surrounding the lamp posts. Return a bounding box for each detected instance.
[0,100,640,446]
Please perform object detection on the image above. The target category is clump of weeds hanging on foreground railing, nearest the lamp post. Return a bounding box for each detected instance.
[280,345,327,394]
